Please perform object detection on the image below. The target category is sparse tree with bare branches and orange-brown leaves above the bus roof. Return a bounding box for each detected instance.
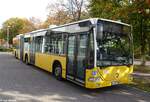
[47,0,88,24]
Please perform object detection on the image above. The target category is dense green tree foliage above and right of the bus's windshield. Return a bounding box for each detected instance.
[89,0,150,65]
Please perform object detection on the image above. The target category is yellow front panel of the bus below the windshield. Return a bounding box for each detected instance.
[85,66,133,88]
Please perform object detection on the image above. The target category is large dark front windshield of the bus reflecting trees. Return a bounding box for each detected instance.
[97,21,133,66]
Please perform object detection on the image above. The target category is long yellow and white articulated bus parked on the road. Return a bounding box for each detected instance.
[14,18,133,89]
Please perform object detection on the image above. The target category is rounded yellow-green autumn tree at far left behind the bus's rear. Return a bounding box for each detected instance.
[1,17,35,44]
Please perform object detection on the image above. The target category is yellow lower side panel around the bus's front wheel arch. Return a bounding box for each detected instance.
[35,53,66,78]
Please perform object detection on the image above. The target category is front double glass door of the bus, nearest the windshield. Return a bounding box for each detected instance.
[67,34,88,84]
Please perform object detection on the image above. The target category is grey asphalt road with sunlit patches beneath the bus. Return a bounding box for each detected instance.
[0,53,150,102]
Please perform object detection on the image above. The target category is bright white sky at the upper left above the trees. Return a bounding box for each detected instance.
[0,0,52,27]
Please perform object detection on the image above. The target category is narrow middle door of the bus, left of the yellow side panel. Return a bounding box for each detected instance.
[30,37,35,64]
